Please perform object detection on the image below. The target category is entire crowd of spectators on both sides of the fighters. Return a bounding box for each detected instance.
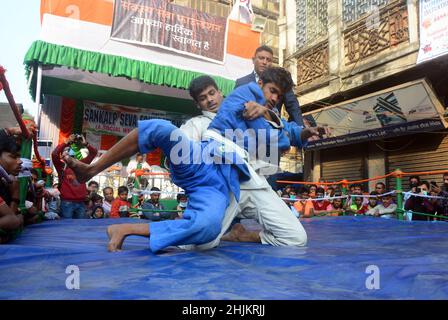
[0,121,448,243]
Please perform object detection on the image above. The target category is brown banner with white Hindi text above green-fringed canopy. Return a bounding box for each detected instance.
[111,0,227,63]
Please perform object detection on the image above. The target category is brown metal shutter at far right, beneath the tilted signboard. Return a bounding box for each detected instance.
[386,133,448,190]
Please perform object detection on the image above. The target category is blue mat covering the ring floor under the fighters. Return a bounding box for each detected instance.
[0,217,448,300]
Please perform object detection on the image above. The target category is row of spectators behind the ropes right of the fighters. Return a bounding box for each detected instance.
[278,176,448,221]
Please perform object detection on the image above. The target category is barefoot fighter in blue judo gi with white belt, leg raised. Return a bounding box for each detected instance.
[65,68,324,252]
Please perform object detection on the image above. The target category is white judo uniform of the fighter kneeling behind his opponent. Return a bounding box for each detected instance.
[180,106,307,250]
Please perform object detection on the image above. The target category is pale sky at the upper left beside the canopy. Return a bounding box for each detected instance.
[0,0,40,116]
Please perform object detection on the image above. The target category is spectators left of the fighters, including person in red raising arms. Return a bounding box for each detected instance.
[0,128,188,243]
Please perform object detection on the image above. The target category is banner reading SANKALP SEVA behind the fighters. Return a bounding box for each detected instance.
[82,101,191,136]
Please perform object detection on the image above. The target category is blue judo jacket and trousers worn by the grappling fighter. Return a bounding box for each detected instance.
[138,83,301,252]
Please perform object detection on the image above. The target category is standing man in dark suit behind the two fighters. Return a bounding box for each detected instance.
[235,45,303,127]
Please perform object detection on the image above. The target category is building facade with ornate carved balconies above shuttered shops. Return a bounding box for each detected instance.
[279,0,448,189]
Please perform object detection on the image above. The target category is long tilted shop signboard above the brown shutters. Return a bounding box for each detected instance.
[304,80,447,149]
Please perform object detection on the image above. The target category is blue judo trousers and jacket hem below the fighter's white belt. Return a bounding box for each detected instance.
[138,119,249,252]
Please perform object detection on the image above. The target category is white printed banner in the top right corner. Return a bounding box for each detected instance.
[417,0,448,63]
